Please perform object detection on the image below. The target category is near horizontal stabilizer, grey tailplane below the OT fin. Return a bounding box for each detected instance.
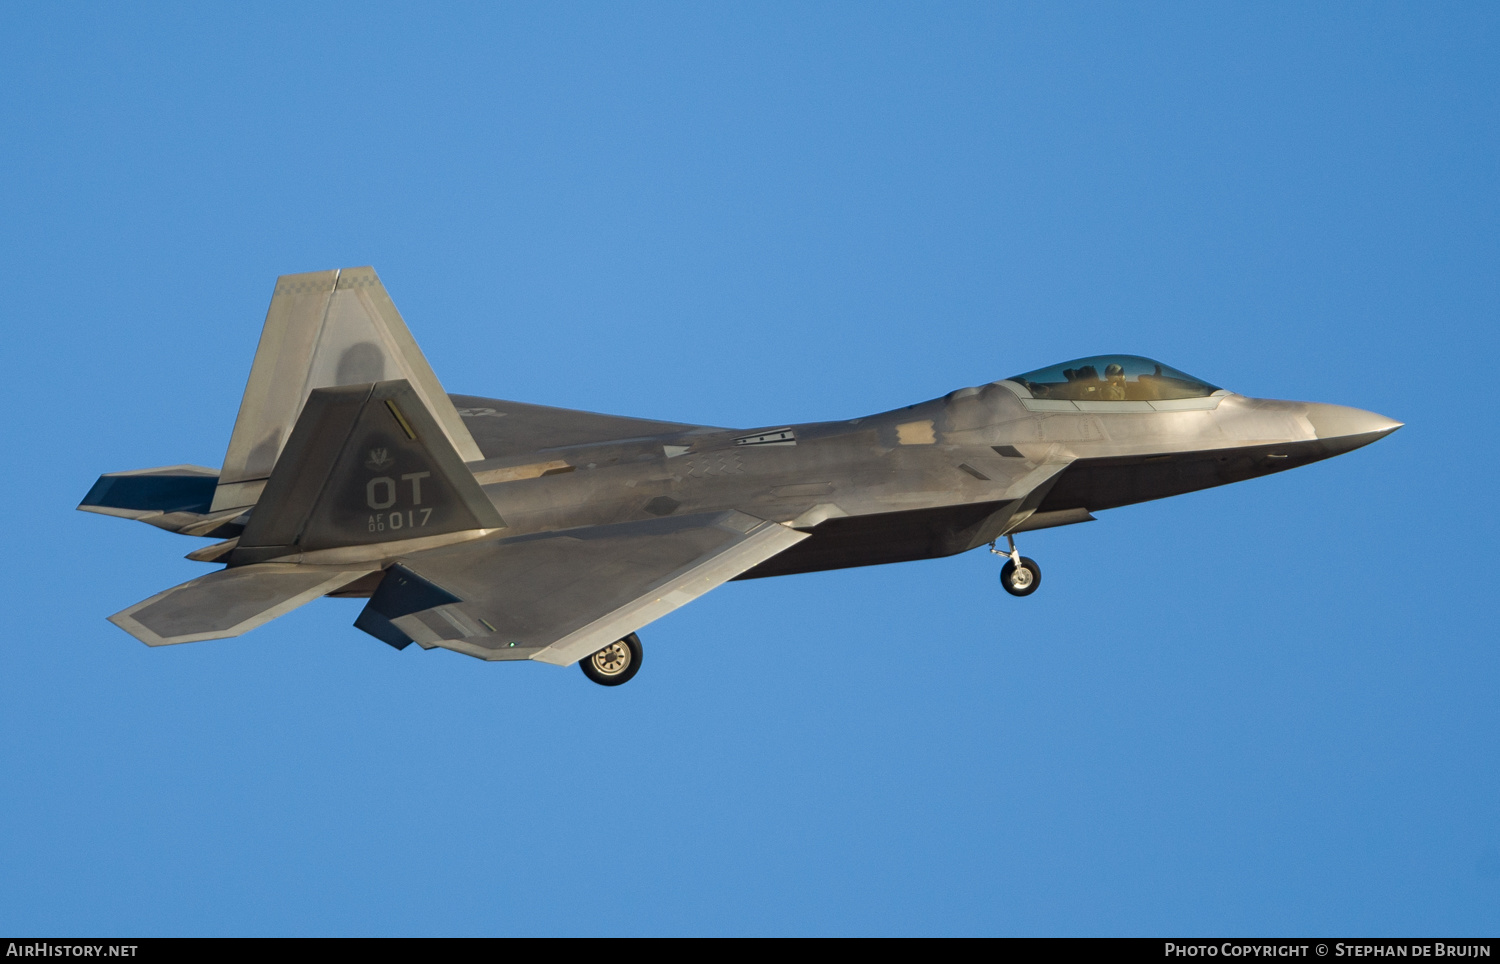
[110,564,372,646]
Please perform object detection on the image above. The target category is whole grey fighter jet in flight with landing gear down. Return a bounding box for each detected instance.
[78,267,1401,685]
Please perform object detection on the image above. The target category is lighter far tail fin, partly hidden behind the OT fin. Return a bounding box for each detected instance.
[212,268,483,511]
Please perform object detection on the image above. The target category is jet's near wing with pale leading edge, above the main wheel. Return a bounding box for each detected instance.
[354,511,807,666]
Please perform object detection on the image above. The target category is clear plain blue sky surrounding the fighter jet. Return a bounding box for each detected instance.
[0,3,1500,936]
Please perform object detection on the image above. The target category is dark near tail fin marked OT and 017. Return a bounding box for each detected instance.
[230,379,506,565]
